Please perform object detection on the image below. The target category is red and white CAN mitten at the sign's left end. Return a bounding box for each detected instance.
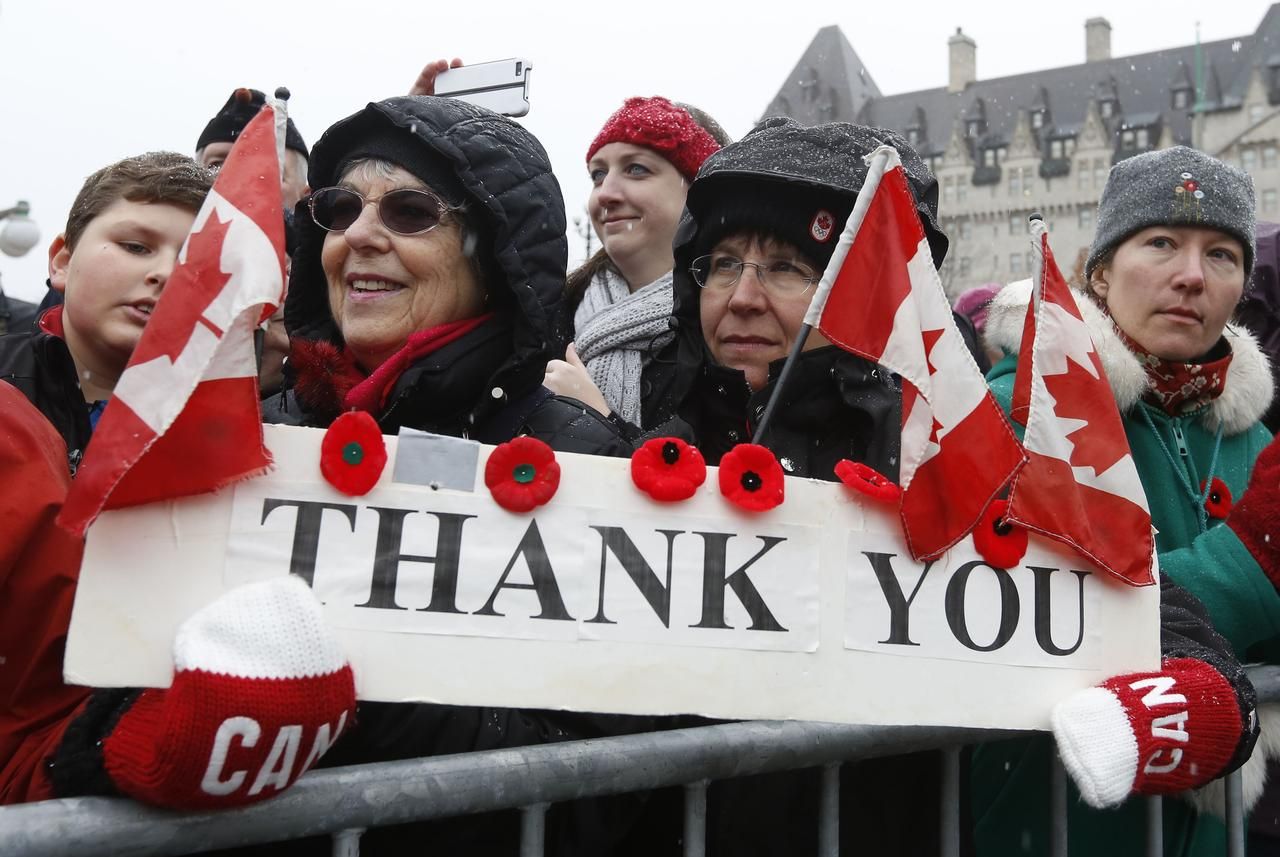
[102,576,356,810]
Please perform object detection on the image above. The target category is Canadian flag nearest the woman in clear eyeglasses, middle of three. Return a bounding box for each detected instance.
[805,146,1027,559]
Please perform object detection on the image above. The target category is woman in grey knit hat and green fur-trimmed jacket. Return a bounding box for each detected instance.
[973,146,1280,856]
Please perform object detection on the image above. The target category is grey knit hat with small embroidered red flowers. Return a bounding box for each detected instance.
[1084,146,1256,283]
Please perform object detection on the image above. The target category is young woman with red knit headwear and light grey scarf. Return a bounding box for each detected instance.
[544,96,730,426]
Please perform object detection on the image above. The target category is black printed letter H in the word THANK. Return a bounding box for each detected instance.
[356,507,475,613]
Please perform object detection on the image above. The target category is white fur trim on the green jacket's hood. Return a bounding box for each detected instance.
[984,280,1275,436]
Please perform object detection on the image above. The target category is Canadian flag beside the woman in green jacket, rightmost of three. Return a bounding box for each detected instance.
[1005,220,1156,586]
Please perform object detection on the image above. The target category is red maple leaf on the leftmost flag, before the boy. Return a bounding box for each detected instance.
[129,208,232,366]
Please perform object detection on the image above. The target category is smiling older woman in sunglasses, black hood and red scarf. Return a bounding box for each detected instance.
[265,96,628,454]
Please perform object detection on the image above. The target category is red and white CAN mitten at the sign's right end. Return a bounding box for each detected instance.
[1052,657,1240,808]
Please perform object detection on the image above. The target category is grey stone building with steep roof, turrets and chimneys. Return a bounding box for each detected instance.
[764,4,1280,295]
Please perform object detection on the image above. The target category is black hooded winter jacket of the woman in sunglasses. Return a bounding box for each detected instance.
[264,97,658,854]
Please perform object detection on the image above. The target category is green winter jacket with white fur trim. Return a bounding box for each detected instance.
[970,280,1280,857]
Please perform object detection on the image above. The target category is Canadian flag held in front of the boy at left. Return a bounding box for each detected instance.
[58,106,284,533]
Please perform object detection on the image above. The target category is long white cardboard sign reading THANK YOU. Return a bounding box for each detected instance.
[65,426,1160,729]
